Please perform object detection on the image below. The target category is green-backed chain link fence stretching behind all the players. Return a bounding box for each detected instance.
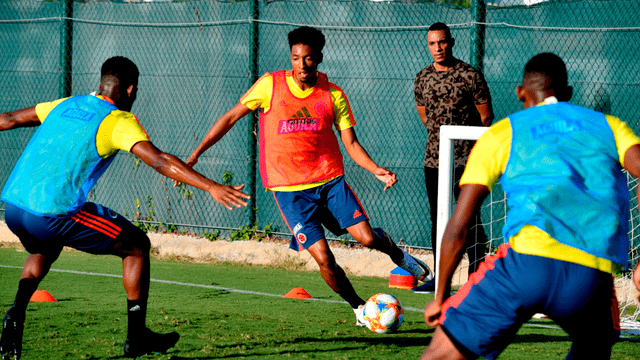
[0,0,640,248]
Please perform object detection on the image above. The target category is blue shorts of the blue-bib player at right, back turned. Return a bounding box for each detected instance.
[440,244,620,359]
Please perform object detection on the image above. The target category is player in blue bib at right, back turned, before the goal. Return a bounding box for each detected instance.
[422,53,640,359]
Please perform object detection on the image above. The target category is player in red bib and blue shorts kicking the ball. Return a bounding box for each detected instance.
[187,27,432,326]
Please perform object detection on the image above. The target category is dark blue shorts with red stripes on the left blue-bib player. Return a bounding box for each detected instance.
[5,202,145,259]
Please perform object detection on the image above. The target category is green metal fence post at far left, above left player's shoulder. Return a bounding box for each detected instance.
[58,0,73,98]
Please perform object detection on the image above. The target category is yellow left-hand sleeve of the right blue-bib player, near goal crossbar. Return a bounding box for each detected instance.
[460,118,511,190]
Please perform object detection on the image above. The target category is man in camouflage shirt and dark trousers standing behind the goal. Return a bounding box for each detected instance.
[414,23,493,291]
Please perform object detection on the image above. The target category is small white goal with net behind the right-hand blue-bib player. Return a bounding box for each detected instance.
[435,125,640,335]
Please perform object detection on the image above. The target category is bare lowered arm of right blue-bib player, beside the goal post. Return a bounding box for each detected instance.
[424,185,489,326]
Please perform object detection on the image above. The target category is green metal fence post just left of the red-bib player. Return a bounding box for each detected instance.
[247,0,260,226]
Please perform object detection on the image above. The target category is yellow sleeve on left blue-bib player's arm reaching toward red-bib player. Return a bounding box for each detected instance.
[96,110,150,158]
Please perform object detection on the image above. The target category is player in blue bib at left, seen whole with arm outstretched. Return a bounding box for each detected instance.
[0,56,249,359]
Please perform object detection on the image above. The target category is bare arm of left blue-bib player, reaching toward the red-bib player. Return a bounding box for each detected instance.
[131,141,250,210]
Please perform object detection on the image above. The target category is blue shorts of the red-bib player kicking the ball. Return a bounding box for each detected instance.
[273,176,369,251]
